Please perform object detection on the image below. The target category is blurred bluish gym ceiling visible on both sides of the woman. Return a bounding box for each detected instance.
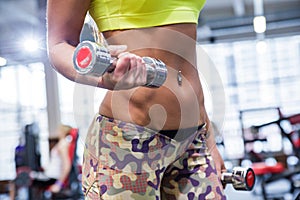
[0,0,300,62]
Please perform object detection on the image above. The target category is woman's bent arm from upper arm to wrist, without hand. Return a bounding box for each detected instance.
[47,0,99,83]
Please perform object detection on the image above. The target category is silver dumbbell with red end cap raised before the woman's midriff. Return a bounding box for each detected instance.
[73,41,167,87]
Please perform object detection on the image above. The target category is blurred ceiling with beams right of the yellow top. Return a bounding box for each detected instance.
[198,0,300,43]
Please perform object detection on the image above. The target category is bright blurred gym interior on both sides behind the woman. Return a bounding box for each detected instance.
[0,0,300,200]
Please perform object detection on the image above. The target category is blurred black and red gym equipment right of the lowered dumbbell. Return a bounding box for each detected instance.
[240,107,300,199]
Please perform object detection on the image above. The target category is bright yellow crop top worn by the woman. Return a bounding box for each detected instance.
[89,0,206,31]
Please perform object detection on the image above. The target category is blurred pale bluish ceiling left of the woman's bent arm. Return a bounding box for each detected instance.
[0,0,46,64]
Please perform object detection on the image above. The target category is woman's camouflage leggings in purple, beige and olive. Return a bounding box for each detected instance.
[82,115,226,200]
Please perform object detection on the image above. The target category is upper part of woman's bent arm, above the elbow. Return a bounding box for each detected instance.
[47,0,90,48]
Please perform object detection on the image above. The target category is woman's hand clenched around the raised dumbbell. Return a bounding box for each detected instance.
[102,45,147,90]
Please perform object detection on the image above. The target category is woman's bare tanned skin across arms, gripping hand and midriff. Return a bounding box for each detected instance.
[47,0,225,178]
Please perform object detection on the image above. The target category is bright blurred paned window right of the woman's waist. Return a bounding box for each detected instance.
[201,36,300,158]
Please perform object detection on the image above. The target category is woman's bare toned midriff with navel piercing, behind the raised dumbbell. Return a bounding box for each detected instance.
[99,24,206,130]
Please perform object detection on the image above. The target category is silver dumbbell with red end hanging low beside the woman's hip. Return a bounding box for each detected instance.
[221,167,255,191]
